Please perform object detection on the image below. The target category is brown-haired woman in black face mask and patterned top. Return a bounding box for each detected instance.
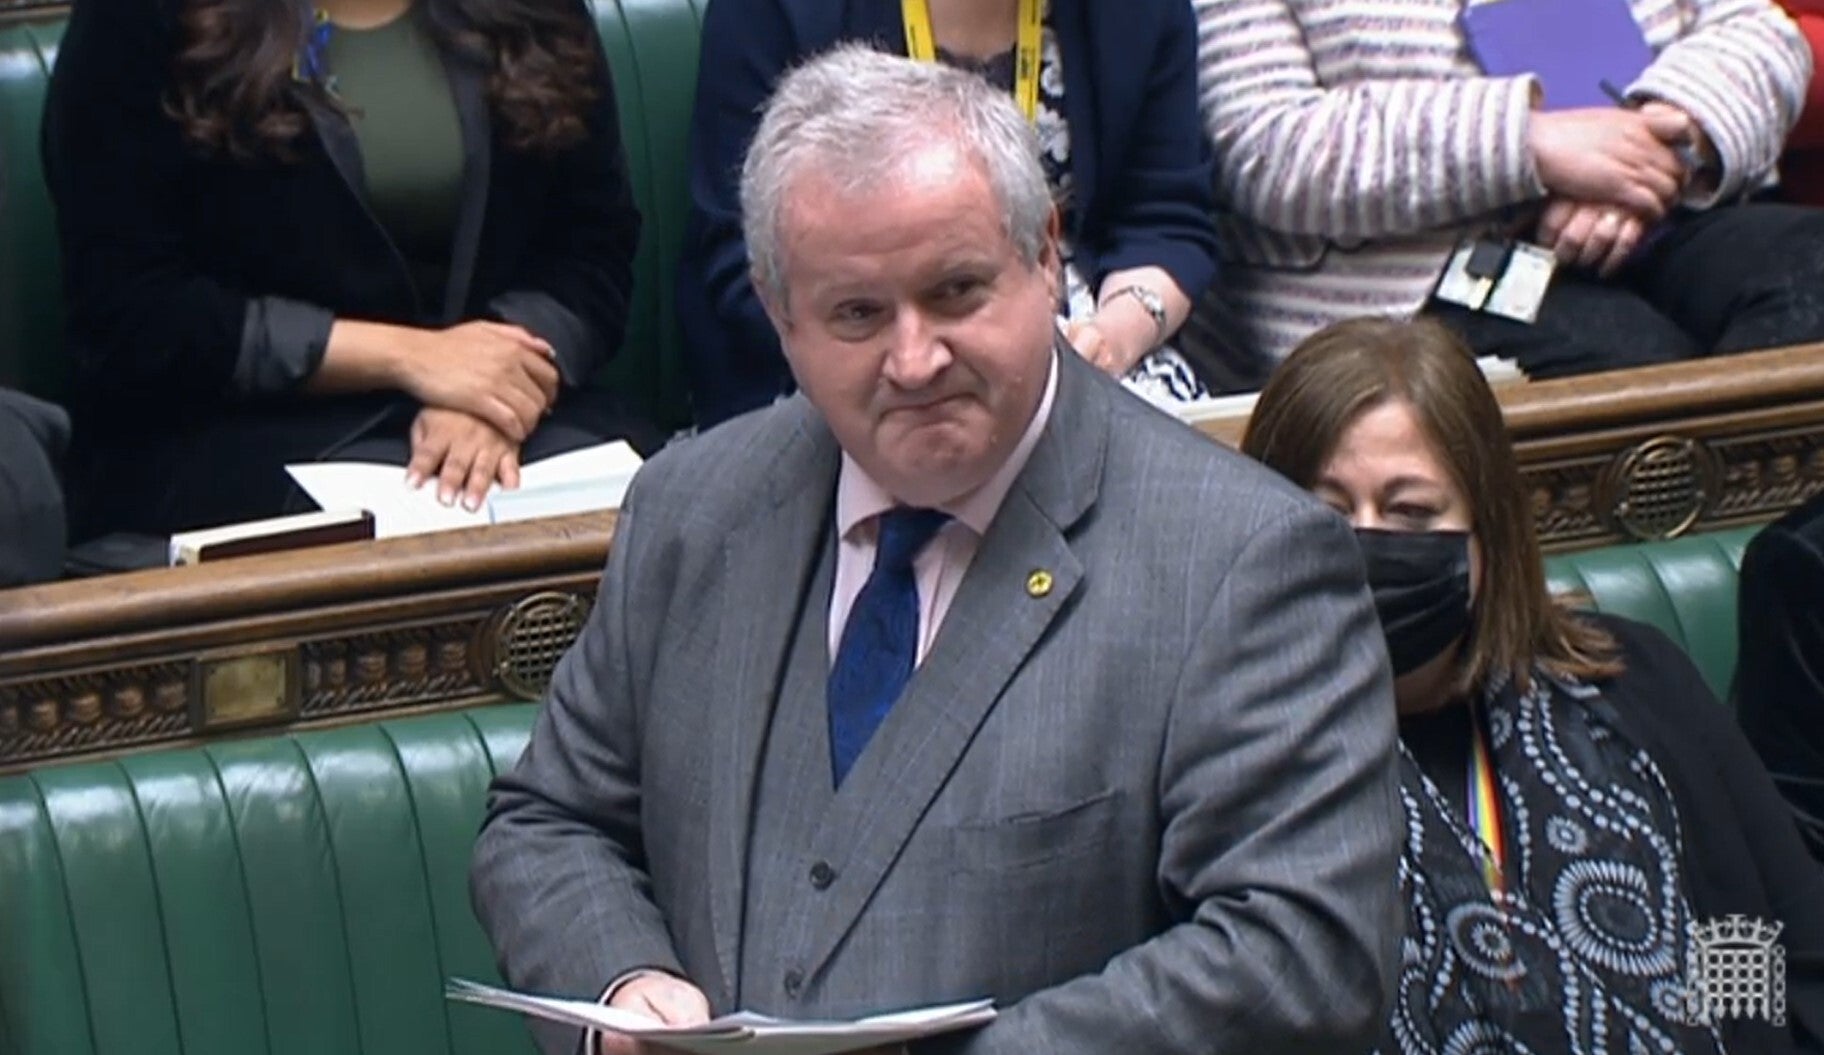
[1242,319,1824,1055]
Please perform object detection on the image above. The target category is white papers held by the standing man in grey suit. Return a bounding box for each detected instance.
[443,978,994,1055]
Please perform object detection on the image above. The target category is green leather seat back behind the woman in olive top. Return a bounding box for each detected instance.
[0,0,706,427]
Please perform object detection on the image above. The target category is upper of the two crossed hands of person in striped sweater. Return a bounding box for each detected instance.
[1527,104,1693,223]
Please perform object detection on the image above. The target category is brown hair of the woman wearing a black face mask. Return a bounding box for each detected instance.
[1242,318,1622,690]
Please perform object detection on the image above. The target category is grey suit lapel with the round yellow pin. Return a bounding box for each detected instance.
[795,354,1109,973]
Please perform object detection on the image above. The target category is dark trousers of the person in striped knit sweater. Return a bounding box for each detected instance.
[1425,203,1824,378]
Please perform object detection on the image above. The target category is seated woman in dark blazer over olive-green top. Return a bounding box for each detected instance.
[44,0,638,537]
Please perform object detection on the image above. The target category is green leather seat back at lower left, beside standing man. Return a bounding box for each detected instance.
[0,705,534,1055]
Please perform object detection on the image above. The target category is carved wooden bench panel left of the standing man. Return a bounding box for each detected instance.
[0,513,613,772]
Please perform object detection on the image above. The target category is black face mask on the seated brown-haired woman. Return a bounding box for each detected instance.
[1355,528,1470,677]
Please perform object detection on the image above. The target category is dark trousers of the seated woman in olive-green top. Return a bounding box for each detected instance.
[71,391,664,540]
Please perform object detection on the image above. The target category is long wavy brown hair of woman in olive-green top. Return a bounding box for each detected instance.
[162,0,600,161]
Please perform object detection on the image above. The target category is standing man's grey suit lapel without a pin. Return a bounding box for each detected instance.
[704,396,839,1000]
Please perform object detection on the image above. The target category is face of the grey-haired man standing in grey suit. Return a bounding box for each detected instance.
[768,144,1058,506]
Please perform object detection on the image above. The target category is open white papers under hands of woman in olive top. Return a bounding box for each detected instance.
[285,444,640,538]
